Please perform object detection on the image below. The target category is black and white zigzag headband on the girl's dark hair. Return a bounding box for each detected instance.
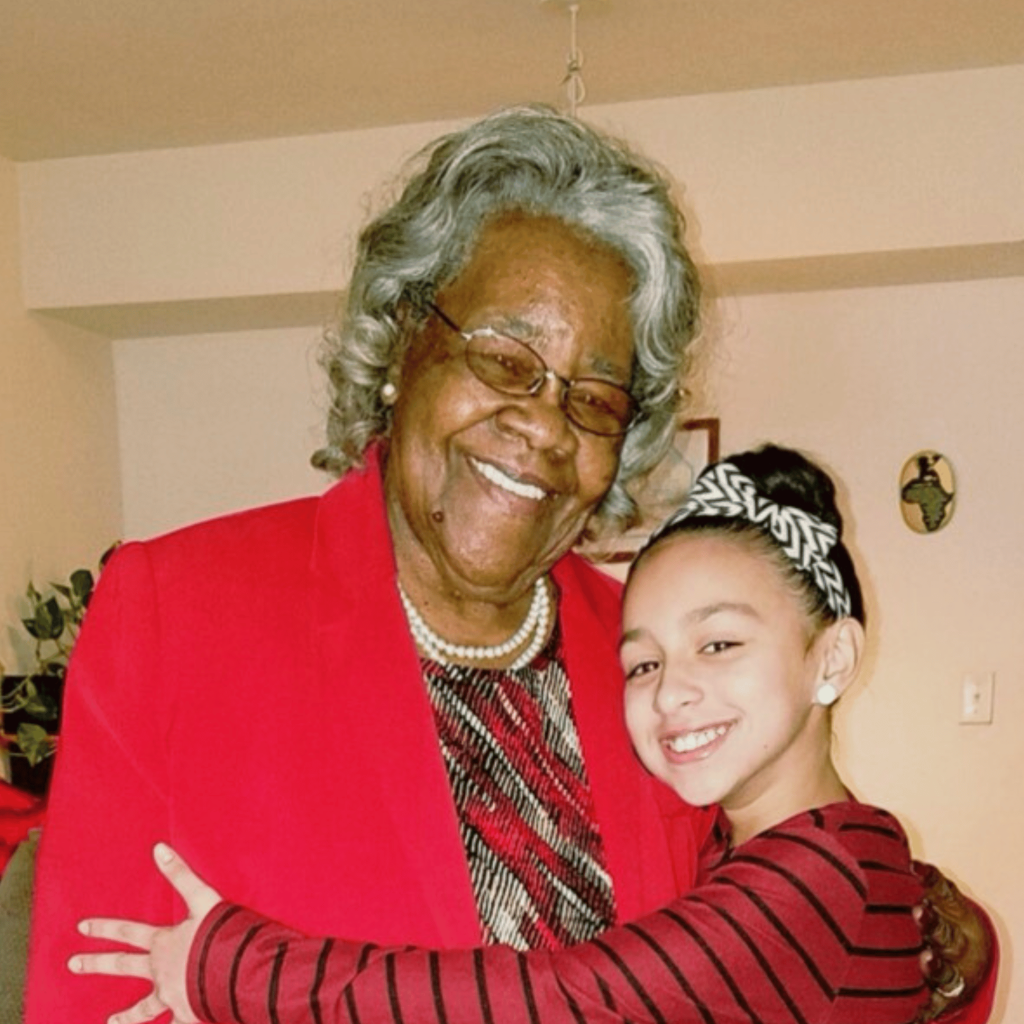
[644,462,852,618]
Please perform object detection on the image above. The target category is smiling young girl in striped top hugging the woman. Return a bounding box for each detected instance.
[72,446,928,1024]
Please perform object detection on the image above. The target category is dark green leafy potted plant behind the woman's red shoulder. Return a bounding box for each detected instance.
[0,569,94,795]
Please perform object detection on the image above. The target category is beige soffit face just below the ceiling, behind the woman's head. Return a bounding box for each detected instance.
[22,65,1024,338]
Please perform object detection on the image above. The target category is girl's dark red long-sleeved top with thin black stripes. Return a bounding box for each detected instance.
[188,804,927,1024]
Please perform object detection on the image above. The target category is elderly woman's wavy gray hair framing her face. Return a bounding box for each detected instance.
[312,106,700,526]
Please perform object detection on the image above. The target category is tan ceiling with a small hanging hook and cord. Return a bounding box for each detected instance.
[0,0,1024,161]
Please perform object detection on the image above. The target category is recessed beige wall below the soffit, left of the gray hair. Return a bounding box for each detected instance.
[109,328,330,537]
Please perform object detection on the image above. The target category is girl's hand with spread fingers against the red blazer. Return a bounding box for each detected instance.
[68,843,220,1024]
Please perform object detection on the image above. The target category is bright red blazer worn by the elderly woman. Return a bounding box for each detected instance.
[27,456,712,1024]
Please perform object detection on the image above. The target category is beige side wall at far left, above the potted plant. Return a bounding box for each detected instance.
[0,160,121,671]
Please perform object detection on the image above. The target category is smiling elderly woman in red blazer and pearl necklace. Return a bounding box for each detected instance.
[28,110,987,1024]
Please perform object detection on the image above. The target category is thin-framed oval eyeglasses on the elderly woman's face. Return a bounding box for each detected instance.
[426,302,636,437]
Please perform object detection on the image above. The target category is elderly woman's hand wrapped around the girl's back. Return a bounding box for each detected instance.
[913,860,992,1021]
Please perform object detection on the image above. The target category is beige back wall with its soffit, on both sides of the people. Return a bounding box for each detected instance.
[9,66,1024,1022]
